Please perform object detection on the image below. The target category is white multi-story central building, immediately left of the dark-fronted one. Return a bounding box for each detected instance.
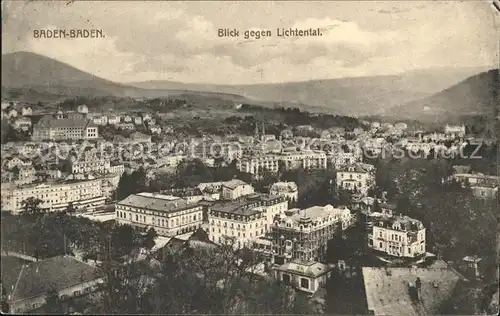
[208,194,288,248]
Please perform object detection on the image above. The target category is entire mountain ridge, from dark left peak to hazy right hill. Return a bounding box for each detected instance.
[2,52,496,116]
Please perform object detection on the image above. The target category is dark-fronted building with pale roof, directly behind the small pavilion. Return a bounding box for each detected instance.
[271,205,352,264]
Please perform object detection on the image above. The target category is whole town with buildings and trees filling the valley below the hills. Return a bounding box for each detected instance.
[1,98,500,315]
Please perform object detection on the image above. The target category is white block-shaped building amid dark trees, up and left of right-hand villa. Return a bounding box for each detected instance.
[337,163,375,195]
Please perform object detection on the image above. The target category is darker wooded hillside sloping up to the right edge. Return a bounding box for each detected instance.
[392,69,500,121]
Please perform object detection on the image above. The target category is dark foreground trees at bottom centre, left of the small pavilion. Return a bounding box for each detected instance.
[86,244,312,315]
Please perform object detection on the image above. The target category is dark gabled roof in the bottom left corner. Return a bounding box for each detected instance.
[2,256,102,302]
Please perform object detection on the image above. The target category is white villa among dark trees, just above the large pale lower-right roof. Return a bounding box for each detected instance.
[368,215,426,258]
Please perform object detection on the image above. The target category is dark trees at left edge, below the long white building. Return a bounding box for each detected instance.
[2,198,156,261]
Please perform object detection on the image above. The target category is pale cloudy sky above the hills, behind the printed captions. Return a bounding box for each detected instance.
[2,0,499,84]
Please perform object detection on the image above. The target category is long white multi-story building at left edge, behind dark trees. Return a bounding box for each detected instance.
[4,177,105,213]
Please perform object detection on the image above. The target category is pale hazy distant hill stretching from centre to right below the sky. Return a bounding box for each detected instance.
[129,68,484,116]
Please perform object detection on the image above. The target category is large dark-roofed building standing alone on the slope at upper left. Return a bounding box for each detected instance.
[31,116,99,141]
